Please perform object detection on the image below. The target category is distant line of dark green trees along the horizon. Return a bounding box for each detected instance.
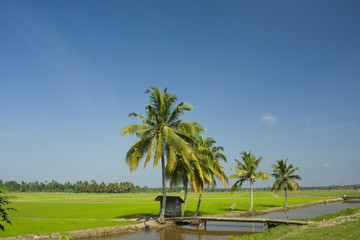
[0,180,360,193]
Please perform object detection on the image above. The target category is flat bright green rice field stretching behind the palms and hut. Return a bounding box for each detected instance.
[0,191,358,238]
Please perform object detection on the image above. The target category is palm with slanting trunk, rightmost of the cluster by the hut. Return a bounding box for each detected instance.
[193,136,228,216]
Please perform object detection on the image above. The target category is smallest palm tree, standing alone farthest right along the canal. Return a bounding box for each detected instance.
[270,159,301,207]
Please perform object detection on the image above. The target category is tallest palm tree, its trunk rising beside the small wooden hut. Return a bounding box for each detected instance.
[121,87,198,223]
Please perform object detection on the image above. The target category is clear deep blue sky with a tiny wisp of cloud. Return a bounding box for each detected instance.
[0,0,360,187]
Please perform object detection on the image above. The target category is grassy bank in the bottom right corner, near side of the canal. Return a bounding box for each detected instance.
[228,208,360,240]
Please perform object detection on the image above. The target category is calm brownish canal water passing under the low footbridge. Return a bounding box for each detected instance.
[82,203,360,240]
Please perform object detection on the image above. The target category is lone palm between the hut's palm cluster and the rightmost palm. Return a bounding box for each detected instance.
[230,151,270,212]
